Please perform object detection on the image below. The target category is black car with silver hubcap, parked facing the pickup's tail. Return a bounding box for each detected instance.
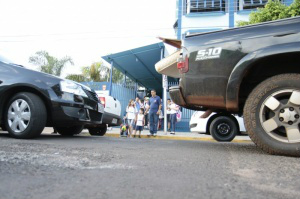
[0,56,104,138]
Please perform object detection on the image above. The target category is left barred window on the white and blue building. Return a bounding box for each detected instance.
[186,0,225,14]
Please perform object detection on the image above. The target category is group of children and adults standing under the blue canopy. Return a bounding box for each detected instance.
[124,89,179,137]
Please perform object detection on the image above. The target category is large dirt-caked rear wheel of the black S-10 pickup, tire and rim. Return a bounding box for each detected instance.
[244,74,300,157]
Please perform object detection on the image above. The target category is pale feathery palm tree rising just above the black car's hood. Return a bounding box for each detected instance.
[29,51,74,76]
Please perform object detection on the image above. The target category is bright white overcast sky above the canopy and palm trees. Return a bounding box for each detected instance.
[0,0,176,75]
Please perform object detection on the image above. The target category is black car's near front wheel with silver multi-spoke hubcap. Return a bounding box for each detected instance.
[4,92,47,139]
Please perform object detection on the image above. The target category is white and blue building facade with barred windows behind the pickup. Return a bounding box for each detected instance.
[174,0,293,39]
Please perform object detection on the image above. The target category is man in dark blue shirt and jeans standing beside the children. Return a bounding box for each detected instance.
[146,89,161,136]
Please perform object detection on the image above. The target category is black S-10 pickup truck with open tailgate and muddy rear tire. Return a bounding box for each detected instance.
[156,17,300,156]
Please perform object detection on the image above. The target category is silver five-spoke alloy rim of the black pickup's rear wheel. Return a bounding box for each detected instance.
[259,89,300,143]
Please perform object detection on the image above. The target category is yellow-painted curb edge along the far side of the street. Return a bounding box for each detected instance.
[105,133,252,143]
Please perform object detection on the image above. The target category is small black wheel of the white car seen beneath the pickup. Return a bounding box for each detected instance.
[209,116,238,142]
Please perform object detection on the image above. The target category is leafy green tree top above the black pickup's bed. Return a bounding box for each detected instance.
[237,0,300,26]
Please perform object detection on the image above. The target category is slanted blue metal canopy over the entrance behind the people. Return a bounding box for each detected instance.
[102,42,165,91]
